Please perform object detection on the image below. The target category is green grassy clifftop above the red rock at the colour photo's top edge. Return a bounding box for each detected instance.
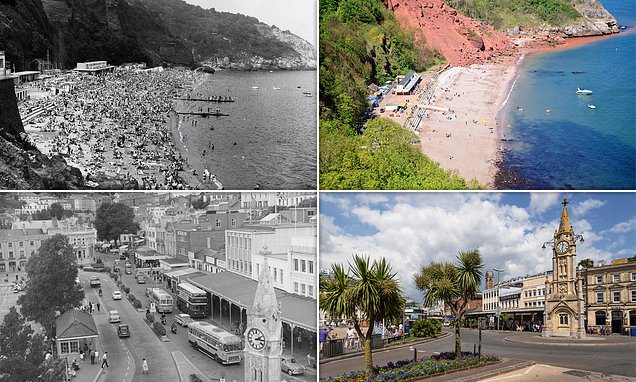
[444,0,581,30]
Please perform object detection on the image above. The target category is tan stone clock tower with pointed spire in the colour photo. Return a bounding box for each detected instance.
[542,198,585,338]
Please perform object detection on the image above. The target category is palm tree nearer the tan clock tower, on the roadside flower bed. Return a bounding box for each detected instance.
[415,249,484,357]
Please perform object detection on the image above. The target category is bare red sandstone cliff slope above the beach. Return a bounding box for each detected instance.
[384,0,513,66]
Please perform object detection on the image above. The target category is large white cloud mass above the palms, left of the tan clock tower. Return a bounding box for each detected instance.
[320,193,558,299]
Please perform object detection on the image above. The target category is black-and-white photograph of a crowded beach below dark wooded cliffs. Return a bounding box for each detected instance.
[0,0,318,190]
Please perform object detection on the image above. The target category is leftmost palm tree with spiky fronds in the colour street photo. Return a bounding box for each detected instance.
[320,255,405,378]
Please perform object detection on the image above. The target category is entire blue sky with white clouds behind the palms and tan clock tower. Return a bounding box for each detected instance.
[320,192,636,301]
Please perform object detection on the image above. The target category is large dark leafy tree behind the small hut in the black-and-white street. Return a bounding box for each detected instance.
[18,234,84,333]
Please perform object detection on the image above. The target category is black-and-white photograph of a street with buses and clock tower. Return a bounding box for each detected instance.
[0,191,318,382]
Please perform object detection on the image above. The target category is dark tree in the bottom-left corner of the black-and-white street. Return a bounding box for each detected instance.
[0,307,64,382]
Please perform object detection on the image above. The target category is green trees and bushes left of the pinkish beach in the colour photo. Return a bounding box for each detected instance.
[319,0,474,190]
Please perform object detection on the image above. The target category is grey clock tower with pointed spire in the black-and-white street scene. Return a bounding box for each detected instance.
[243,248,283,382]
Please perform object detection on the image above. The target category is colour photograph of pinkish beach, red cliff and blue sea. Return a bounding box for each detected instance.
[319,0,636,190]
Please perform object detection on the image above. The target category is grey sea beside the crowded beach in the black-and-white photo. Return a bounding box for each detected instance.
[176,70,317,190]
